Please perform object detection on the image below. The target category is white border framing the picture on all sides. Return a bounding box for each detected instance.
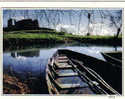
[0,2,125,99]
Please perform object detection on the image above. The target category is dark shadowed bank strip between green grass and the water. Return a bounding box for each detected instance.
[3,37,122,50]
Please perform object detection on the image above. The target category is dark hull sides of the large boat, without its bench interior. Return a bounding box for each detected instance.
[46,49,122,94]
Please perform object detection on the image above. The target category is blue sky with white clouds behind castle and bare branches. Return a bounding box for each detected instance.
[3,8,122,35]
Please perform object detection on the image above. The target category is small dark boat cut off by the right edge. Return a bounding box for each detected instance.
[102,51,122,66]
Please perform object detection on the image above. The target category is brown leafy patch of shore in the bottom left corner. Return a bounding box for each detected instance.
[3,73,31,95]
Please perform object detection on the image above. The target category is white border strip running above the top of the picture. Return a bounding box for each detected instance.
[0,2,125,8]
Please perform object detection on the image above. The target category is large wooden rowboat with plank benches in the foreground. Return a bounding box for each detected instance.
[46,49,122,95]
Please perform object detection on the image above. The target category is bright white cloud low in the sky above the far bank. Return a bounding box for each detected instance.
[56,23,116,36]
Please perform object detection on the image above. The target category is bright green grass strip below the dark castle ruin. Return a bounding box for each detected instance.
[4,30,122,40]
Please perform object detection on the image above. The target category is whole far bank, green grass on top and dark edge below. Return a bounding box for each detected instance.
[3,30,122,49]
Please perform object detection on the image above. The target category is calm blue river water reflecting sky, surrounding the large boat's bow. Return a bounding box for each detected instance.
[3,44,122,94]
